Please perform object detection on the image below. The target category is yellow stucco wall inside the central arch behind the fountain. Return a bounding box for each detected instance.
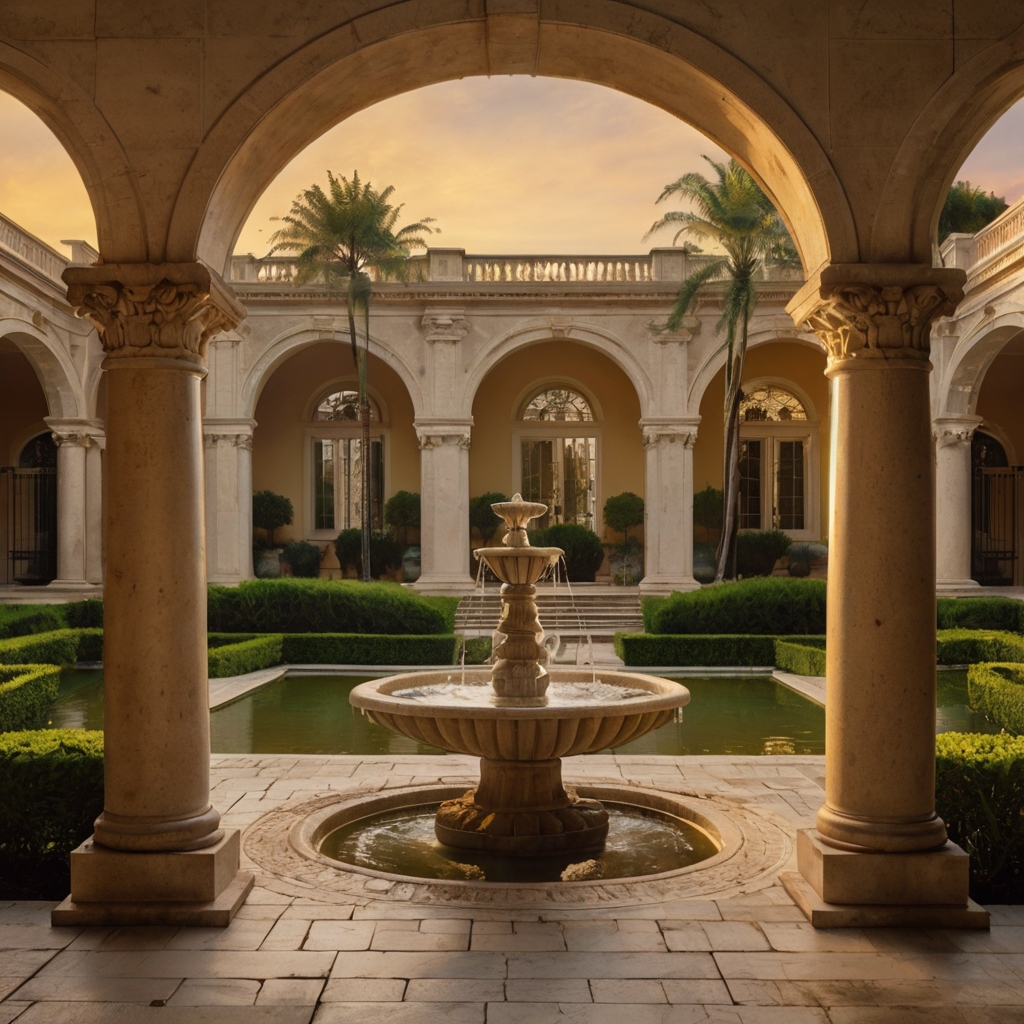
[469,341,644,542]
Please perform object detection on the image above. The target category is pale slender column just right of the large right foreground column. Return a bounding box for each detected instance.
[934,416,981,592]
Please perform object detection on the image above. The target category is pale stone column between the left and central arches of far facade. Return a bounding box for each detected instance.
[414,420,473,595]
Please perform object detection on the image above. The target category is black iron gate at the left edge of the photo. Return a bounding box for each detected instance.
[0,466,57,586]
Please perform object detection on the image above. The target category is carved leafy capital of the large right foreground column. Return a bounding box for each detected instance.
[787,263,965,368]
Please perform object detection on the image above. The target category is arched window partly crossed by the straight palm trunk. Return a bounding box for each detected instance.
[311,388,384,537]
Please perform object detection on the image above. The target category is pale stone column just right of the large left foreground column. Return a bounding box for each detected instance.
[203,418,256,584]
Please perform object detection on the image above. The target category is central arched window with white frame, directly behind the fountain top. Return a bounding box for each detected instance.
[519,385,597,529]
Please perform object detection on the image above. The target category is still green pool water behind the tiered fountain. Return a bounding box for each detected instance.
[49,670,999,755]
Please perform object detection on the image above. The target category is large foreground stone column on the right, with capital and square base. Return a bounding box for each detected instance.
[783,264,987,927]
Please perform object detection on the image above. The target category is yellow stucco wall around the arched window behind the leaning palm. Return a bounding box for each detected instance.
[693,341,828,537]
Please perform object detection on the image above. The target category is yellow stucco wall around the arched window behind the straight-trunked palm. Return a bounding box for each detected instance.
[253,341,420,544]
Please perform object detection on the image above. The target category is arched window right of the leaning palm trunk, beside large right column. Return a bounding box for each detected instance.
[739,381,819,540]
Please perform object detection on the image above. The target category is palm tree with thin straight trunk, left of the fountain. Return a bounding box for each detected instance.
[270,171,434,581]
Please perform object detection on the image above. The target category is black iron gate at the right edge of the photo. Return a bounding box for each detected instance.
[971,466,1024,587]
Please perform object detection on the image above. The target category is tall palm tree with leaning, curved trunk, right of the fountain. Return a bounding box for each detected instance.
[644,157,800,582]
